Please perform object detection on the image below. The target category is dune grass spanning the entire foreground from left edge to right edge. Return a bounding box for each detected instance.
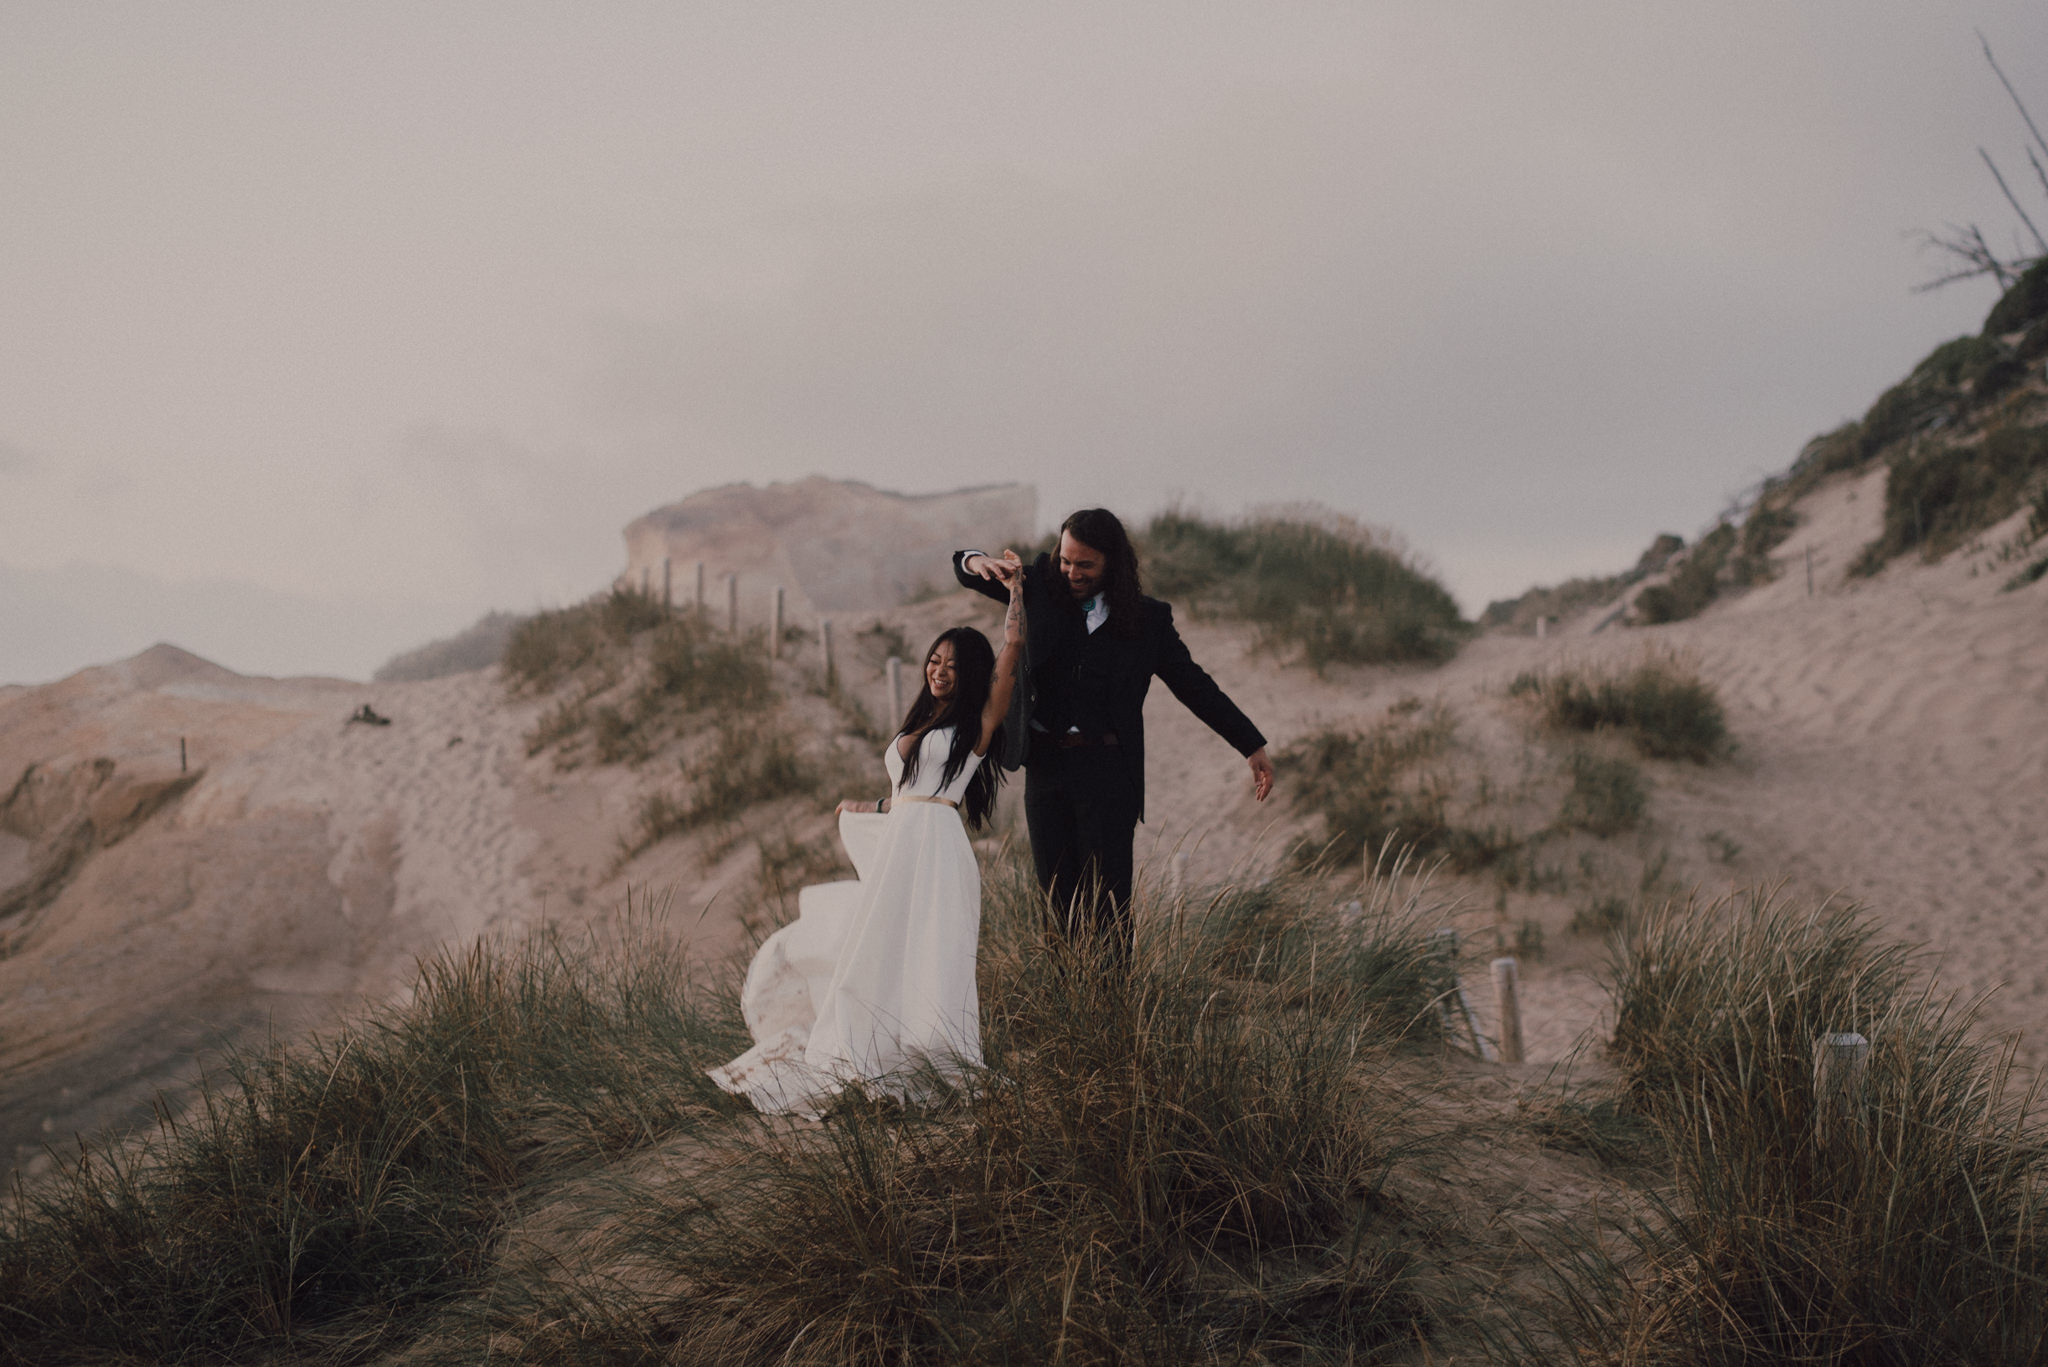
[0,851,2048,1367]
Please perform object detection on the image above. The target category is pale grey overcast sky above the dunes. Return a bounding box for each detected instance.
[0,0,2048,680]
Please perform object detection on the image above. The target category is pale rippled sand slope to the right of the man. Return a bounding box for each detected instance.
[1141,469,2048,1066]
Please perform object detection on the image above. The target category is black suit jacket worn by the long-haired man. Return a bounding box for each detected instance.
[952,551,1266,820]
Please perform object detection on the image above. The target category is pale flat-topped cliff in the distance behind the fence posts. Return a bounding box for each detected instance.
[621,475,1038,621]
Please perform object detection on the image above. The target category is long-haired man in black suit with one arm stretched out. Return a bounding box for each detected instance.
[952,508,1274,955]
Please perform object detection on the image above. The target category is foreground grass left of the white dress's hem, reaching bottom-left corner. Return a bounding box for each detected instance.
[0,918,745,1367]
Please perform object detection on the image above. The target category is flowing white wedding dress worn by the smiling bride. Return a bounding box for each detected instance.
[711,726,981,1117]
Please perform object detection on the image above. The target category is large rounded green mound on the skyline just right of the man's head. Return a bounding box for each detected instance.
[1141,512,1468,668]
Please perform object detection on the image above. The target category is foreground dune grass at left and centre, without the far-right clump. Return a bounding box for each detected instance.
[0,857,1474,1363]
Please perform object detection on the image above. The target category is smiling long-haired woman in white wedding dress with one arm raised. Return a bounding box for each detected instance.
[711,555,1024,1117]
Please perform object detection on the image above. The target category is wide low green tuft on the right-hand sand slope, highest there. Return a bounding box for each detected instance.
[1507,656,1729,764]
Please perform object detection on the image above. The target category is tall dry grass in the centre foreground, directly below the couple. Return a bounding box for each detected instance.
[464,861,1438,1365]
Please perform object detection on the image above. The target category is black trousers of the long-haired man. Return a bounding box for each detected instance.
[1024,734,1139,957]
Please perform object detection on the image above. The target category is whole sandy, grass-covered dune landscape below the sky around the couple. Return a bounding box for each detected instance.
[0,317,2048,1367]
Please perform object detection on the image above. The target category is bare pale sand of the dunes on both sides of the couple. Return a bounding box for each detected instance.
[0,471,2048,1160]
